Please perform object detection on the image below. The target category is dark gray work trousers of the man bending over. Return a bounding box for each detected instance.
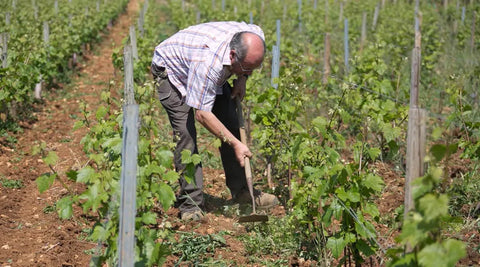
[152,65,248,212]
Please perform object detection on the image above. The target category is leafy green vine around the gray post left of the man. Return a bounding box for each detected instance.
[32,80,178,266]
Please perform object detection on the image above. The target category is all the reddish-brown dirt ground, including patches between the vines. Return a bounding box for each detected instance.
[0,0,480,267]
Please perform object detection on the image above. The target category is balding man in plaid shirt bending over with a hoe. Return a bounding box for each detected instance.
[152,22,278,221]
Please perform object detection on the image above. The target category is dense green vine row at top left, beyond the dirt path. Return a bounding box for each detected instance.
[0,0,128,124]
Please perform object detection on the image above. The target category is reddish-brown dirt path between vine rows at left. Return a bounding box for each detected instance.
[0,0,140,266]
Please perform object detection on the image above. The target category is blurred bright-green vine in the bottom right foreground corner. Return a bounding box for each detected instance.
[388,148,466,266]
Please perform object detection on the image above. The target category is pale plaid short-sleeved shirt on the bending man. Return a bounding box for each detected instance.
[152,21,265,111]
